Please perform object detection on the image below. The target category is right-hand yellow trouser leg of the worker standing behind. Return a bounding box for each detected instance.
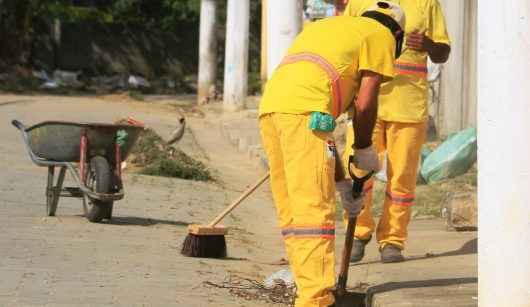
[377,122,426,249]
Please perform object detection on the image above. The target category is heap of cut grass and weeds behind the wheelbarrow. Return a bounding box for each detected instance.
[130,129,213,181]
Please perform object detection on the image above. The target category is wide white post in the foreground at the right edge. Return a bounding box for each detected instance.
[478,0,530,307]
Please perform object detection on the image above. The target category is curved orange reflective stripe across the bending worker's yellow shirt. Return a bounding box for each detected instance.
[280,52,342,118]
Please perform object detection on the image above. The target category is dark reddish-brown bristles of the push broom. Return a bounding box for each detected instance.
[180,233,226,258]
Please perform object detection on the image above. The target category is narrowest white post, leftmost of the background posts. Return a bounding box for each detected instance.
[197,0,218,104]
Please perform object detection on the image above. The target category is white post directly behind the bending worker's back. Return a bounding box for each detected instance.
[267,0,303,78]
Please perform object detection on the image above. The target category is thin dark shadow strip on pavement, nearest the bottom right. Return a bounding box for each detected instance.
[366,277,478,307]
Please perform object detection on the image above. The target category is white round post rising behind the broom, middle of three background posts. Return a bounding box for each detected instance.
[223,0,250,111]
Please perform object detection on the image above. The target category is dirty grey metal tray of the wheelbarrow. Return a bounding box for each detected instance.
[26,121,143,162]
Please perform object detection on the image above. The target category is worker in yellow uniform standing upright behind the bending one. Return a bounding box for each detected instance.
[343,0,450,263]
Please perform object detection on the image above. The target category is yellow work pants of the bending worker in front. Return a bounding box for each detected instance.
[259,113,335,307]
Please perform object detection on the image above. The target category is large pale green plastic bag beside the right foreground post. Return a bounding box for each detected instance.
[421,128,477,183]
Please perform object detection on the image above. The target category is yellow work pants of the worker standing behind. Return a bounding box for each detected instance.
[342,120,426,249]
